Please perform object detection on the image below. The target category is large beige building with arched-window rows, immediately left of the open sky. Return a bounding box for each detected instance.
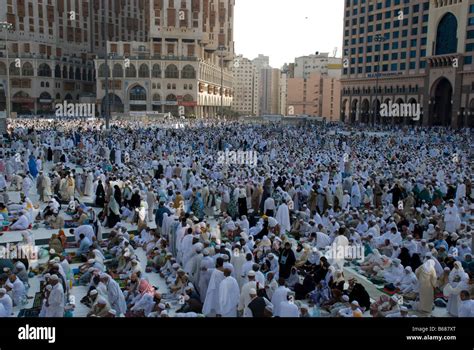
[96,0,235,117]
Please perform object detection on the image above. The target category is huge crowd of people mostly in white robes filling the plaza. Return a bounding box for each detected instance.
[0,119,474,317]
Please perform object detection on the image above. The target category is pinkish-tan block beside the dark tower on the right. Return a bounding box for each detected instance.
[287,73,340,121]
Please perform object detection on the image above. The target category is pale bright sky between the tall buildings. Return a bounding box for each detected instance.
[234,0,344,68]
